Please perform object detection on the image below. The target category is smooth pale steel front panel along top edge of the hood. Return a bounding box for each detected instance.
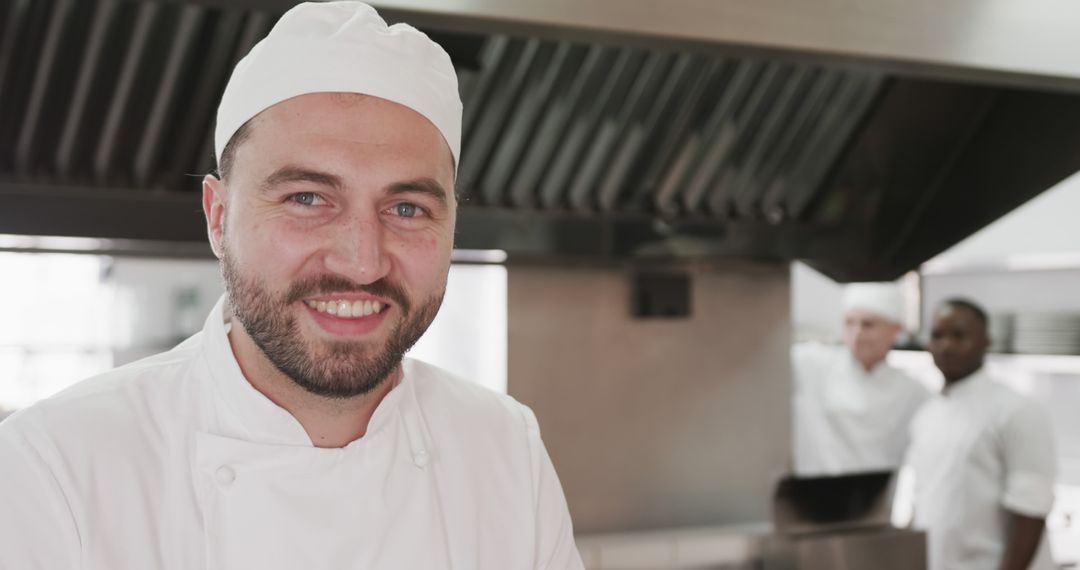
[367,0,1080,90]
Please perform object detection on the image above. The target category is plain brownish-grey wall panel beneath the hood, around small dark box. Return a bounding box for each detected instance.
[508,263,791,533]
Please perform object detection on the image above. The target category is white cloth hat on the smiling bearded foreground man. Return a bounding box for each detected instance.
[214,1,461,169]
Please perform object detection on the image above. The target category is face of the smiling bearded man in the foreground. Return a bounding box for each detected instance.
[203,94,457,397]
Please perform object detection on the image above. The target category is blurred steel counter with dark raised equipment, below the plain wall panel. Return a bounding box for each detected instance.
[578,472,927,570]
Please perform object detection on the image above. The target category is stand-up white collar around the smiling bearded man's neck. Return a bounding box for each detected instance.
[197,295,415,447]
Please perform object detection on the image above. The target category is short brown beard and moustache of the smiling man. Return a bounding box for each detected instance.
[221,250,445,399]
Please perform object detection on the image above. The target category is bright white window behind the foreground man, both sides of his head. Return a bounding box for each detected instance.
[0,252,507,417]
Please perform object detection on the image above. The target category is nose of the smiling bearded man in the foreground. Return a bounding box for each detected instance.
[323,213,390,285]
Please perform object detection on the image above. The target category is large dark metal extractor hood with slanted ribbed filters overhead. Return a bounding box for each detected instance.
[0,0,1080,281]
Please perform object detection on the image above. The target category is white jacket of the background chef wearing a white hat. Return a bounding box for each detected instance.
[792,343,930,476]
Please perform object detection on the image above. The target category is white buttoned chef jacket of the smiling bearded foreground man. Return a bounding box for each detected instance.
[0,301,582,570]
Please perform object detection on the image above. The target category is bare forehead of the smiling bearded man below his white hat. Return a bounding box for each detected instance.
[237,93,455,182]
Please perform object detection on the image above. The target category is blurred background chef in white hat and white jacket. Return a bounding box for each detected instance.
[792,283,930,476]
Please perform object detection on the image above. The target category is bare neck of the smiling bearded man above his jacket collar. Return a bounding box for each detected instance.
[229,325,402,447]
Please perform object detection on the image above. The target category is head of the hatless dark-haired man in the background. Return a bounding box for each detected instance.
[929,304,990,382]
